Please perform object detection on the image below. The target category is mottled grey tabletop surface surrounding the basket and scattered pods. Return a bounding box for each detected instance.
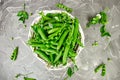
[0,0,120,80]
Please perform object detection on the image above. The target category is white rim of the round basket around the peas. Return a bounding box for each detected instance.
[28,10,85,70]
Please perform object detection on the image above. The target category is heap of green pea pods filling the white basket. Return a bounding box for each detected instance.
[27,12,83,67]
